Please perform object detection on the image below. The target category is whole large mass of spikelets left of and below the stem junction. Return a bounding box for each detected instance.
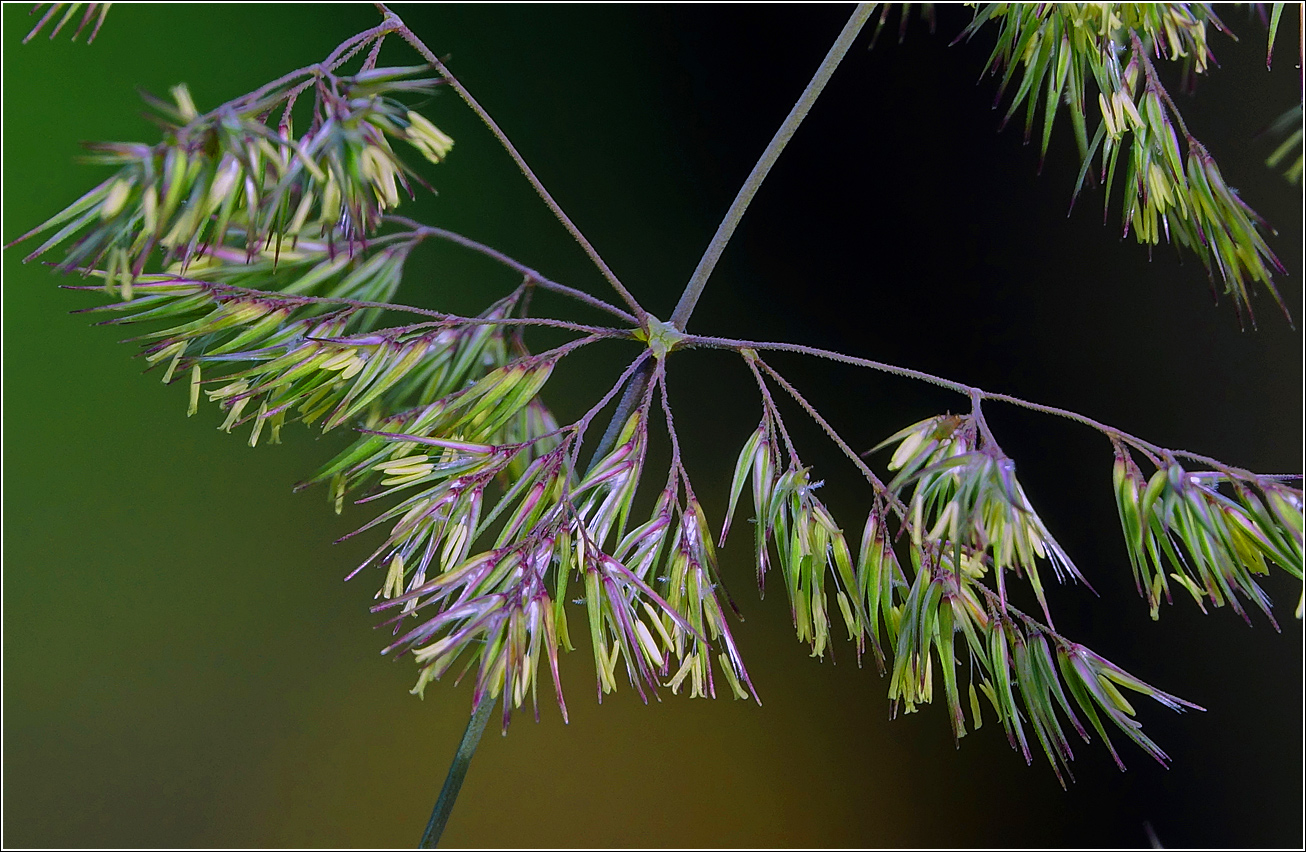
[7,11,751,723]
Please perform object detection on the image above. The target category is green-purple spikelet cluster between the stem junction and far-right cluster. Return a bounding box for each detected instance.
[721,381,1217,783]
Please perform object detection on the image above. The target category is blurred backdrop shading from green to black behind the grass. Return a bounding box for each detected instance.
[3,4,1306,847]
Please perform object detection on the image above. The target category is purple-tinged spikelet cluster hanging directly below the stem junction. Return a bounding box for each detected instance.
[299,355,752,725]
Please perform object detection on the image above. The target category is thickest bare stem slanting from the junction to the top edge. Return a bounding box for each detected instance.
[670,3,875,331]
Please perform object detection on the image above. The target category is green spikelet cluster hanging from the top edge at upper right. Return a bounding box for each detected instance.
[959,3,1288,323]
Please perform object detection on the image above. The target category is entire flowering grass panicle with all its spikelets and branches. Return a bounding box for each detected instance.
[7,4,1303,825]
